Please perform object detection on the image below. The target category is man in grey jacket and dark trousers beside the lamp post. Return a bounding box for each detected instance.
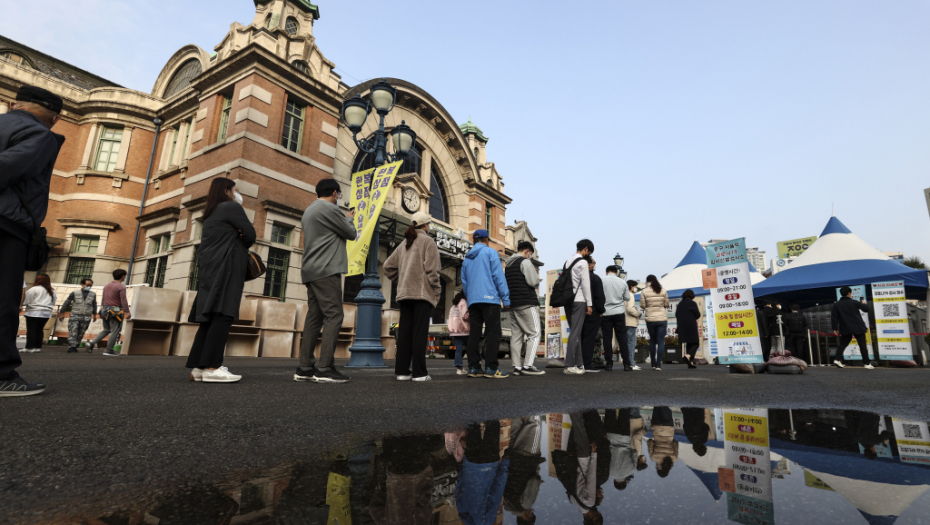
[294,179,358,383]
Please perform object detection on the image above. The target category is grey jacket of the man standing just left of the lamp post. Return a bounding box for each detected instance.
[300,199,356,283]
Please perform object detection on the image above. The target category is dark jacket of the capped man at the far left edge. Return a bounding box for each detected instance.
[0,109,65,243]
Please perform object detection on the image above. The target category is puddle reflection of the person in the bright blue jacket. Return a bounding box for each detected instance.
[455,419,510,525]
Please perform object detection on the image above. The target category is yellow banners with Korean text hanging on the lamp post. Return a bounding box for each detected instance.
[346,160,403,277]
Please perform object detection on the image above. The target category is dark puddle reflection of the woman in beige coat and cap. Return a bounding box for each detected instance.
[368,436,433,525]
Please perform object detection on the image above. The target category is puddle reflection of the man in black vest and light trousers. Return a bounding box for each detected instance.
[504,416,546,525]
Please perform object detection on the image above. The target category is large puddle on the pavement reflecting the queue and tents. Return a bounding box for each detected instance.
[75,406,930,525]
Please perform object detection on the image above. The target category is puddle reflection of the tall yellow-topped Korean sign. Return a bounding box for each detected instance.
[721,408,775,525]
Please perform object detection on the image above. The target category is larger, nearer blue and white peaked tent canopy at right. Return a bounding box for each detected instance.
[752,217,928,303]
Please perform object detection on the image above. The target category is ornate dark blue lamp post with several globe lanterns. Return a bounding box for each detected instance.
[342,79,417,368]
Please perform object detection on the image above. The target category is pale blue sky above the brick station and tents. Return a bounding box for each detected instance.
[0,0,930,279]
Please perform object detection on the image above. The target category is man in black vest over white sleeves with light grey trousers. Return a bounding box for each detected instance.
[504,241,546,376]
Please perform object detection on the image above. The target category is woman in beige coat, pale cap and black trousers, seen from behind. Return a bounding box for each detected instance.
[384,212,441,381]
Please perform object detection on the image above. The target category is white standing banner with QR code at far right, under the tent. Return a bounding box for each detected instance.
[872,281,914,361]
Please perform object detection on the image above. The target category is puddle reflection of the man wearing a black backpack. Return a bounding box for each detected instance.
[552,411,604,525]
